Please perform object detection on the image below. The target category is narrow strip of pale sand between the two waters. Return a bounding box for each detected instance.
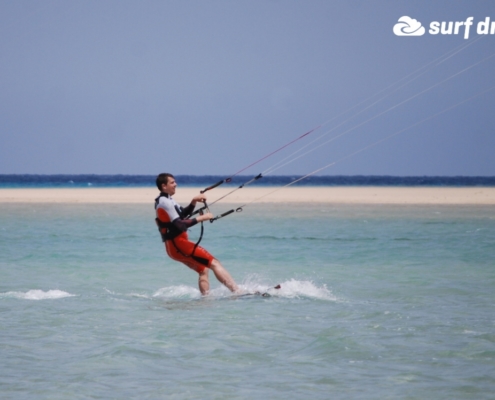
[0,186,495,205]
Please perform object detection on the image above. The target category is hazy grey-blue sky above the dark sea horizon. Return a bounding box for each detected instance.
[0,0,495,175]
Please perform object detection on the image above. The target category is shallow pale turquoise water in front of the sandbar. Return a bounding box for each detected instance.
[0,199,495,400]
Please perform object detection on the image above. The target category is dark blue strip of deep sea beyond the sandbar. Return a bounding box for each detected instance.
[0,174,495,188]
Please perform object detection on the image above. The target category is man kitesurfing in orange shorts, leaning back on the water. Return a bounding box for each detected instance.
[155,173,239,295]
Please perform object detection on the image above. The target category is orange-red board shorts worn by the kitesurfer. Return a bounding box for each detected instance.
[165,232,215,274]
